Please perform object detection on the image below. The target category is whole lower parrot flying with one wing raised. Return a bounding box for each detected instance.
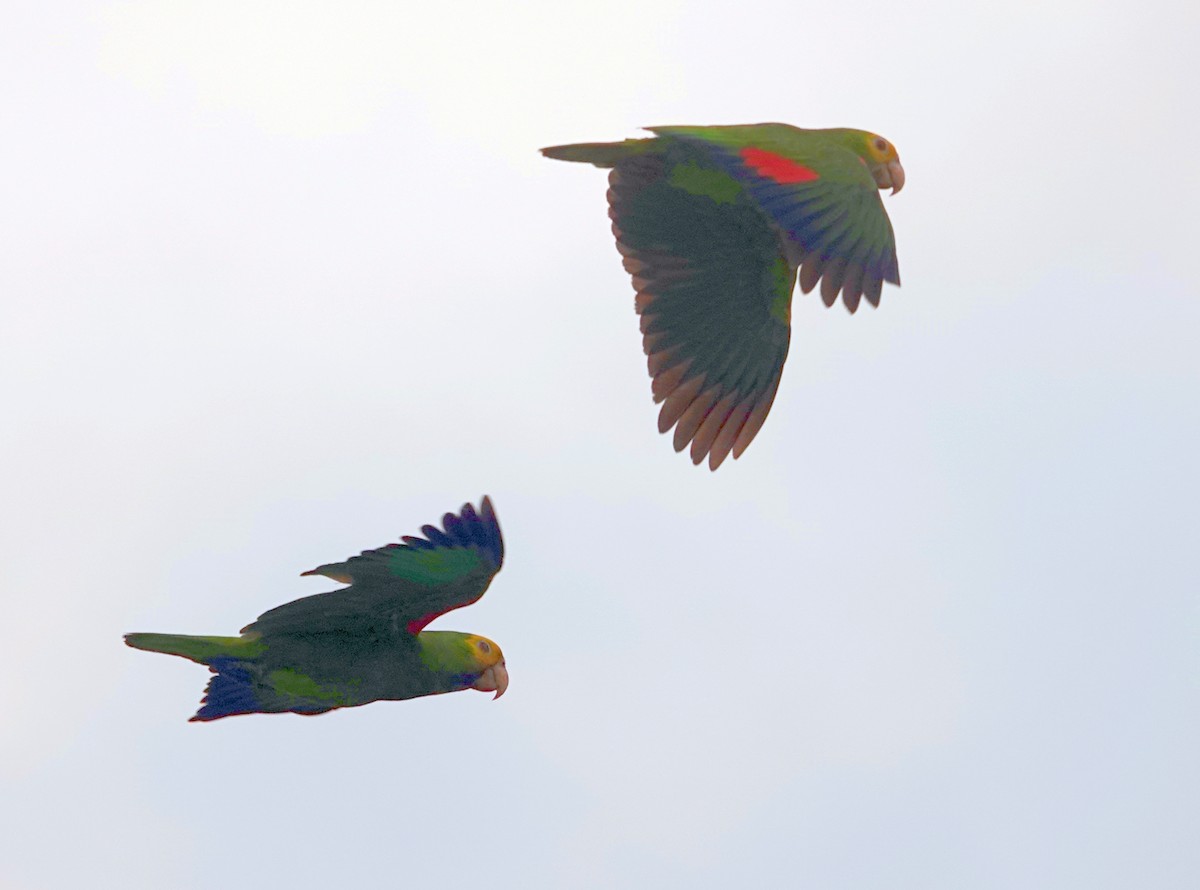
[125,497,509,721]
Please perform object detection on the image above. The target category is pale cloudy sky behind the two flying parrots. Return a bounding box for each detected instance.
[0,0,1200,890]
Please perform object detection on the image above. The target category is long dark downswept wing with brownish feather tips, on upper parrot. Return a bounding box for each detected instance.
[608,143,796,470]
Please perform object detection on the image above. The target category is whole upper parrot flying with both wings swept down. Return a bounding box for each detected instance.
[541,124,904,470]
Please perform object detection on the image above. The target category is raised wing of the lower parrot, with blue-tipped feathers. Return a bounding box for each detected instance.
[242,497,504,638]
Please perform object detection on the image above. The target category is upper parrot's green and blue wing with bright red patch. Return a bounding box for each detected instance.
[652,124,900,312]
